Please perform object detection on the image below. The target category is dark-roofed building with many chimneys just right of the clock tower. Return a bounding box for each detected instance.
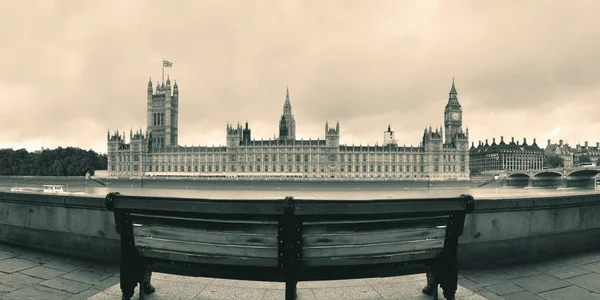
[469,137,544,173]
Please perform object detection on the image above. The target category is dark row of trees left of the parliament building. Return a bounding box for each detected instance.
[0,147,107,176]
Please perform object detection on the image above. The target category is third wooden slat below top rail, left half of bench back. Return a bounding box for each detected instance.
[135,237,278,258]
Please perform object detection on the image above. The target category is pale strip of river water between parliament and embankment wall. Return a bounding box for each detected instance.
[0,178,596,200]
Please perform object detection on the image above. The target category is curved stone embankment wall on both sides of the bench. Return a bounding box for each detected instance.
[0,193,600,267]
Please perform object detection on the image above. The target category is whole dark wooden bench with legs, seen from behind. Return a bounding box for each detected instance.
[106,193,474,300]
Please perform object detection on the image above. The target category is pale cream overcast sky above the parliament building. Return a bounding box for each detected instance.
[0,0,600,152]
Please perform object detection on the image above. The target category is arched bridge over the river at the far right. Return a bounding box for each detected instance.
[500,166,600,188]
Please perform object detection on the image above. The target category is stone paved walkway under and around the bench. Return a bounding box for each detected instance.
[0,243,600,300]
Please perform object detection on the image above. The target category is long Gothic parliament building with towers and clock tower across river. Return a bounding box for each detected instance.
[107,78,469,180]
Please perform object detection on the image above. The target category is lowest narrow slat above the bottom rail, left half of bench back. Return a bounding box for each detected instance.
[139,248,279,267]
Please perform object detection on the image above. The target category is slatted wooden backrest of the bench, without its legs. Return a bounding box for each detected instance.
[106,193,473,277]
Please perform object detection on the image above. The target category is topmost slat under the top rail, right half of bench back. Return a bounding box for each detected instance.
[302,216,448,236]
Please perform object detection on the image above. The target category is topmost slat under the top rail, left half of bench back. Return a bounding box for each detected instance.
[131,214,277,236]
